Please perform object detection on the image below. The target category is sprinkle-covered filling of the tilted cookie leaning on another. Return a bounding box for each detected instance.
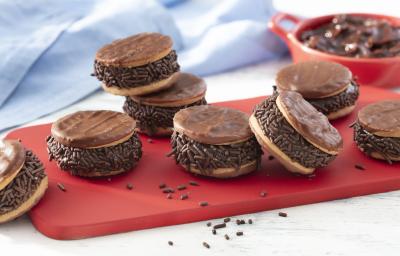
[254,92,336,168]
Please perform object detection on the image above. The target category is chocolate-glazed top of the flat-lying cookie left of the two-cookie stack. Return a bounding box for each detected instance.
[51,110,135,148]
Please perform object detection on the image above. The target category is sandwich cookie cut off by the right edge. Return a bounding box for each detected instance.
[353,100,400,163]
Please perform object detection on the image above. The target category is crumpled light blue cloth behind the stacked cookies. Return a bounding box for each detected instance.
[0,0,286,131]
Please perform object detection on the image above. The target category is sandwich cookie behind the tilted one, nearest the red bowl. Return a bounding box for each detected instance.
[276,61,359,120]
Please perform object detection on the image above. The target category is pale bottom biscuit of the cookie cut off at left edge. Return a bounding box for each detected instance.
[0,176,49,223]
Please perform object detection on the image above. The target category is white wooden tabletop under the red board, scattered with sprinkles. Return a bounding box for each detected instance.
[0,60,400,256]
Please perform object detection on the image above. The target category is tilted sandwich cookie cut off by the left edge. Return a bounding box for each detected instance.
[0,140,48,223]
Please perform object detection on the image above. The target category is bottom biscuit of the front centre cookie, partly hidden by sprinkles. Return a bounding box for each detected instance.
[183,160,257,179]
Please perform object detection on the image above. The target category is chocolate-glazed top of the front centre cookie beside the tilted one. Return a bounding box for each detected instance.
[174,105,254,145]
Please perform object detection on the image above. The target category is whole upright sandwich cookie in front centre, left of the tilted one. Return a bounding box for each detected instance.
[170,105,262,178]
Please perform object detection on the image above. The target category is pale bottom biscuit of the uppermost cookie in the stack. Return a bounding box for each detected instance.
[102,73,177,96]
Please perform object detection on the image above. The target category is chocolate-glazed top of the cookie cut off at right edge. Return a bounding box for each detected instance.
[358,100,400,133]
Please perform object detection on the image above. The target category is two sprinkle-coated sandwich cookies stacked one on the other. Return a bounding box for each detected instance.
[94,33,207,136]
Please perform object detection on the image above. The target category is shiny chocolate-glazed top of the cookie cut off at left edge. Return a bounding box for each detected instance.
[0,140,25,182]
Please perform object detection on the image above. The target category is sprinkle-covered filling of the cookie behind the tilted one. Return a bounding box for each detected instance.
[306,81,360,115]
